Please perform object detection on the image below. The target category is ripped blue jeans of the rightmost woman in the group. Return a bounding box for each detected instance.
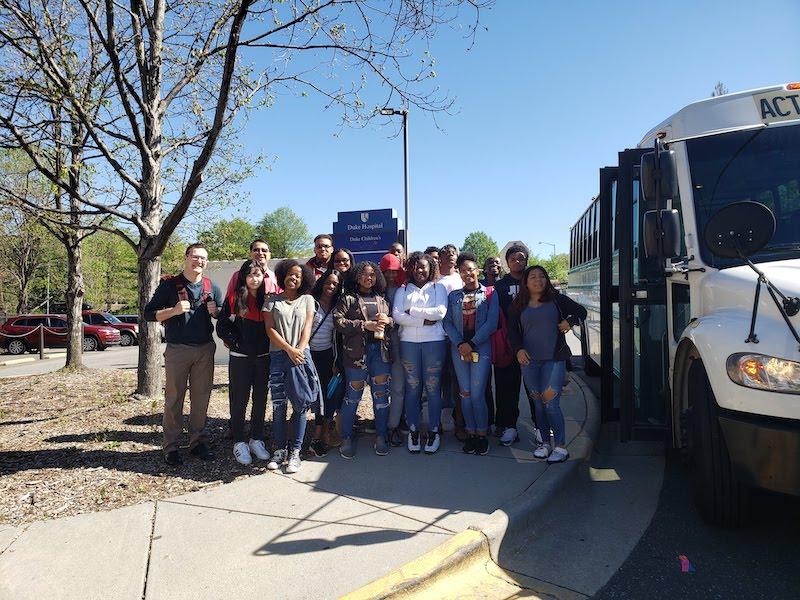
[521,360,567,446]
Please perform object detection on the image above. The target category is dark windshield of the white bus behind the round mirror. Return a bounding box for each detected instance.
[686,125,800,268]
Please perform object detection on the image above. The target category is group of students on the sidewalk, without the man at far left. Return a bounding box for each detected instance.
[211,235,586,473]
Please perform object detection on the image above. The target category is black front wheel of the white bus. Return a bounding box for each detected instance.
[688,360,749,527]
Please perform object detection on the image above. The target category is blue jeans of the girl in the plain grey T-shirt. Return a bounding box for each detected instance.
[269,349,315,450]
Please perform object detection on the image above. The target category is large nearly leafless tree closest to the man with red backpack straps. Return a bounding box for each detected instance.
[0,0,489,397]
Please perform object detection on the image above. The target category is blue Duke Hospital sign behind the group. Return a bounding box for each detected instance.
[333,208,398,262]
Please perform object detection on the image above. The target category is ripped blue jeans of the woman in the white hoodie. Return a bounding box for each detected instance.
[400,340,447,431]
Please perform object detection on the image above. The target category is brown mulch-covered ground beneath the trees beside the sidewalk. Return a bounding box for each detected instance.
[0,367,372,525]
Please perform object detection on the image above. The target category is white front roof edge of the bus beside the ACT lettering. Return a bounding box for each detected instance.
[639,84,800,148]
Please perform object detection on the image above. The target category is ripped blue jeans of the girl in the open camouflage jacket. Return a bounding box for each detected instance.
[341,342,392,439]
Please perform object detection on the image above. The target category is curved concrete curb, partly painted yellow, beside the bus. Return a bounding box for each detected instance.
[342,373,600,600]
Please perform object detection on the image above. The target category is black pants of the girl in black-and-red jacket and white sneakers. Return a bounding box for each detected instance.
[228,354,269,442]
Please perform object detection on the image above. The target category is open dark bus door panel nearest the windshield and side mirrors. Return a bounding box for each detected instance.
[612,149,670,441]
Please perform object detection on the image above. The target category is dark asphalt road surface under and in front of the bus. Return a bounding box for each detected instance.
[595,442,800,600]
